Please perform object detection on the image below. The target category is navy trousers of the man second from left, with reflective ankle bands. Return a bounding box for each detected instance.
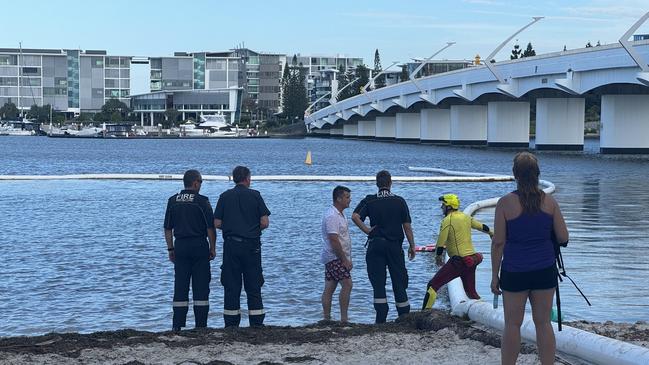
[221,237,265,327]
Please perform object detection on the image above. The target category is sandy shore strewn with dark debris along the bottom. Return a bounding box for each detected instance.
[0,310,649,365]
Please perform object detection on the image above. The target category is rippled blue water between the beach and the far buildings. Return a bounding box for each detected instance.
[0,137,649,336]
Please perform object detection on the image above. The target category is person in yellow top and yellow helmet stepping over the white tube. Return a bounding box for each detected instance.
[422,194,493,310]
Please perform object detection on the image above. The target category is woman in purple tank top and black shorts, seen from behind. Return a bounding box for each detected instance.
[491,152,568,364]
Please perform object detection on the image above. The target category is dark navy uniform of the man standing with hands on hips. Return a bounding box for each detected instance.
[354,189,411,323]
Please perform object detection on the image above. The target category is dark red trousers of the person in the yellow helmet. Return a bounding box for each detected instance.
[428,253,482,299]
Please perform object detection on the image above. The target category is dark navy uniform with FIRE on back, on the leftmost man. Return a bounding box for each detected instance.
[164,190,214,328]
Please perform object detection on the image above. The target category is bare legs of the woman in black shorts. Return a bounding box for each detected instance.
[500,288,556,365]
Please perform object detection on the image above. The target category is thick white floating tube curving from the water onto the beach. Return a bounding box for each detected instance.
[409,167,649,365]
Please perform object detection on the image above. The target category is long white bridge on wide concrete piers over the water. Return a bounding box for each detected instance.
[305,13,649,154]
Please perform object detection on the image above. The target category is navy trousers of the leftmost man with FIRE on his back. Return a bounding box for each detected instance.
[173,238,212,328]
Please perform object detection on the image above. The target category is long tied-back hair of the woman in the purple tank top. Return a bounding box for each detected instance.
[512,152,545,213]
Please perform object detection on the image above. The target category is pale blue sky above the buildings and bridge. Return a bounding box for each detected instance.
[5,0,649,94]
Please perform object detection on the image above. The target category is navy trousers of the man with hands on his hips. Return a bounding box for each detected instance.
[365,238,410,323]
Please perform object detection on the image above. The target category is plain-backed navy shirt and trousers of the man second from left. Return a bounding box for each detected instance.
[214,184,270,327]
